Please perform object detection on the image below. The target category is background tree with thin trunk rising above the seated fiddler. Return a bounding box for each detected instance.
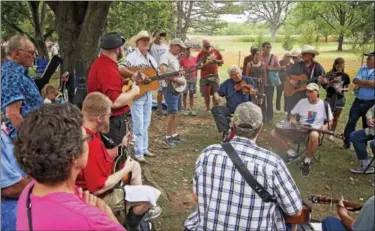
[242,1,292,42]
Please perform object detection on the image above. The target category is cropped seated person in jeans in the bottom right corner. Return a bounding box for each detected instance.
[322,196,375,231]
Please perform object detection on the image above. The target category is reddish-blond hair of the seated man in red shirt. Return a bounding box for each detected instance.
[82,92,112,117]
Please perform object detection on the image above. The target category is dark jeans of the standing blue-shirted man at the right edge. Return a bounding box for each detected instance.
[344,98,375,144]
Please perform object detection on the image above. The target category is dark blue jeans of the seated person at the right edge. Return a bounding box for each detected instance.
[350,129,375,160]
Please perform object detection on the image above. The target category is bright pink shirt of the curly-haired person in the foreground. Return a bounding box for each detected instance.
[16,181,125,230]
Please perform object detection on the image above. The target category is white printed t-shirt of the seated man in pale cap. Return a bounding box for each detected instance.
[291,98,333,129]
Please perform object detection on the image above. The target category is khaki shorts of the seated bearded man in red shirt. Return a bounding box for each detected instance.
[102,188,135,225]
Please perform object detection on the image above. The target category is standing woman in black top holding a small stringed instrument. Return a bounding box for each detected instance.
[322,58,350,140]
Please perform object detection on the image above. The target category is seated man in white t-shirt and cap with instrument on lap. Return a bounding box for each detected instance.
[271,83,333,176]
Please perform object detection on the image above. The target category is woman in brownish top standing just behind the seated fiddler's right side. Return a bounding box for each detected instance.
[245,47,266,118]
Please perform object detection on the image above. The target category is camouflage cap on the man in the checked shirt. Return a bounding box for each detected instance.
[232,102,263,131]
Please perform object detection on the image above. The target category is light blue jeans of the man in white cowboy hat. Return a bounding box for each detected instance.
[130,91,152,157]
